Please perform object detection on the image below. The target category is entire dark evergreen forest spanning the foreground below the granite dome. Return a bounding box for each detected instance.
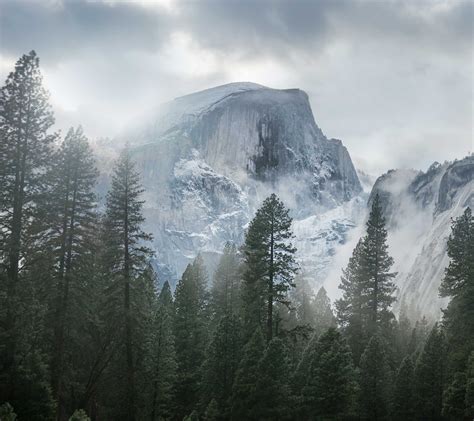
[0,52,474,421]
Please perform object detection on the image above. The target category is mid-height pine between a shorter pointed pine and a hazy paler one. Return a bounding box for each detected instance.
[173,256,209,417]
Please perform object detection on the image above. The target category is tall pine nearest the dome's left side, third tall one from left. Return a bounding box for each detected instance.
[104,149,152,420]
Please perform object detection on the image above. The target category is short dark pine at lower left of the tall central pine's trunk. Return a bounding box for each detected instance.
[231,328,265,420]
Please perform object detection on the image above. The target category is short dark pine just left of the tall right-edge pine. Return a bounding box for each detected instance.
[415,325,446,420]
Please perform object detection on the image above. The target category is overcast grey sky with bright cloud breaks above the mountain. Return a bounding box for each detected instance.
[0,0,474,174]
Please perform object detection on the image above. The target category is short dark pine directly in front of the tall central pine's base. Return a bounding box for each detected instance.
[255,338,291,420]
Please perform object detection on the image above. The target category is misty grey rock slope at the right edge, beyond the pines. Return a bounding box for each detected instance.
[369,155,474,319]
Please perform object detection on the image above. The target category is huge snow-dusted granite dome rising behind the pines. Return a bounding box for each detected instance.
[119,83,364,279]
